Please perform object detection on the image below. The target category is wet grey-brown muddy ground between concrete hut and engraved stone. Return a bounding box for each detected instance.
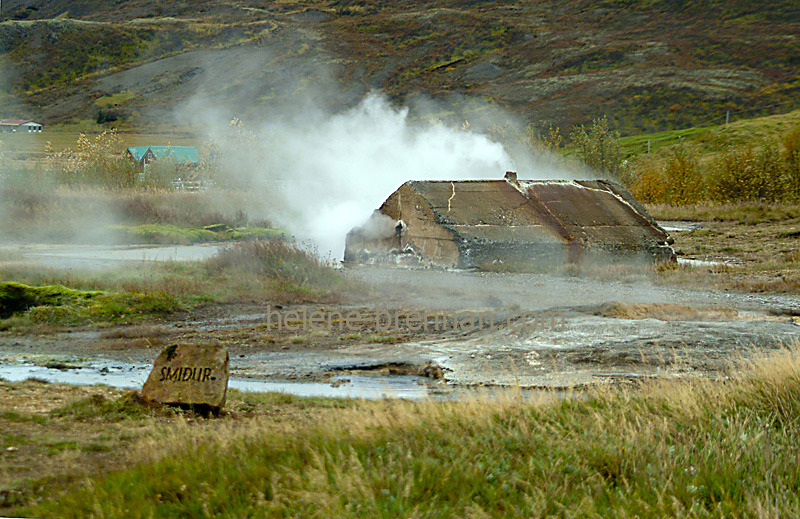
[0,267,800,395]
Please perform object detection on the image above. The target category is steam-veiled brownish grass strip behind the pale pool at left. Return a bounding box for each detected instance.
[0,178,285,244]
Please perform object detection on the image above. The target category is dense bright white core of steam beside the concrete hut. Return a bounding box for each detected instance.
[206,94,514,258]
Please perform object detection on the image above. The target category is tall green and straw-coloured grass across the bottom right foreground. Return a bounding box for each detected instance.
[12,345,800,517]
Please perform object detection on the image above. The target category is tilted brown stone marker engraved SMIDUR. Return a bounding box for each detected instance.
[142,344,229,413]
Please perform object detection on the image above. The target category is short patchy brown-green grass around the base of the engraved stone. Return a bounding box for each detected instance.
[0,379,358,517]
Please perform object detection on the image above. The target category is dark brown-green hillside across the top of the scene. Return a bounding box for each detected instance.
[0,0,800,135]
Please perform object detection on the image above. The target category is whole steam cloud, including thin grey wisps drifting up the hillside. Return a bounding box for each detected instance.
[152,38,566,258]
